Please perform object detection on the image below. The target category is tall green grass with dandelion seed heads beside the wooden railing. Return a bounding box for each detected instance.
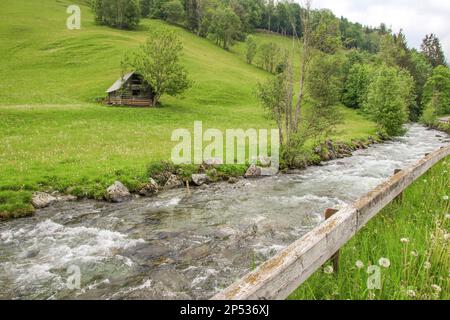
[289,157,450,300]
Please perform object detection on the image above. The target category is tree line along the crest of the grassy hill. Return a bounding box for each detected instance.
[91,0,398,53]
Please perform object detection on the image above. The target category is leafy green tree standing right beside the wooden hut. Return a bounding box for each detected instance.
[128,29,192,105]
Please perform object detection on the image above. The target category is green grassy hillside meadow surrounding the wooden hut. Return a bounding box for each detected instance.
[0,0,375,218]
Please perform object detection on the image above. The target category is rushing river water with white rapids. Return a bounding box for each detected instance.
[0,125,450,299]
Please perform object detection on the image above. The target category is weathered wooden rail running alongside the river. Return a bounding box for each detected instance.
[212,146,450,300]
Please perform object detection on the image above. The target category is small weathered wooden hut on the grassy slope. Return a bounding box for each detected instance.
[106,72,154,107]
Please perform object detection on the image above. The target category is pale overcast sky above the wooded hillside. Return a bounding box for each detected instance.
[313,0,450,61]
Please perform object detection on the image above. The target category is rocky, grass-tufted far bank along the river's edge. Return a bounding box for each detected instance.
[0,132,383,219]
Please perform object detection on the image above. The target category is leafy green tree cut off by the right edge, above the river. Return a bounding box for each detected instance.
[423,66,450,116]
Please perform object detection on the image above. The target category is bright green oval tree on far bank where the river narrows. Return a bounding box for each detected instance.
[364,65,408,136]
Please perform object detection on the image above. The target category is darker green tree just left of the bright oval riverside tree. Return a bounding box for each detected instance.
[342,63,373,109]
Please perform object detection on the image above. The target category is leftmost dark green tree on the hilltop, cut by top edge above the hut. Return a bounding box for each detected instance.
[91,0,140,29]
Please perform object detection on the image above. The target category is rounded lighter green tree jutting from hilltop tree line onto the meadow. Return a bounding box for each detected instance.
[208,7,241,50]
